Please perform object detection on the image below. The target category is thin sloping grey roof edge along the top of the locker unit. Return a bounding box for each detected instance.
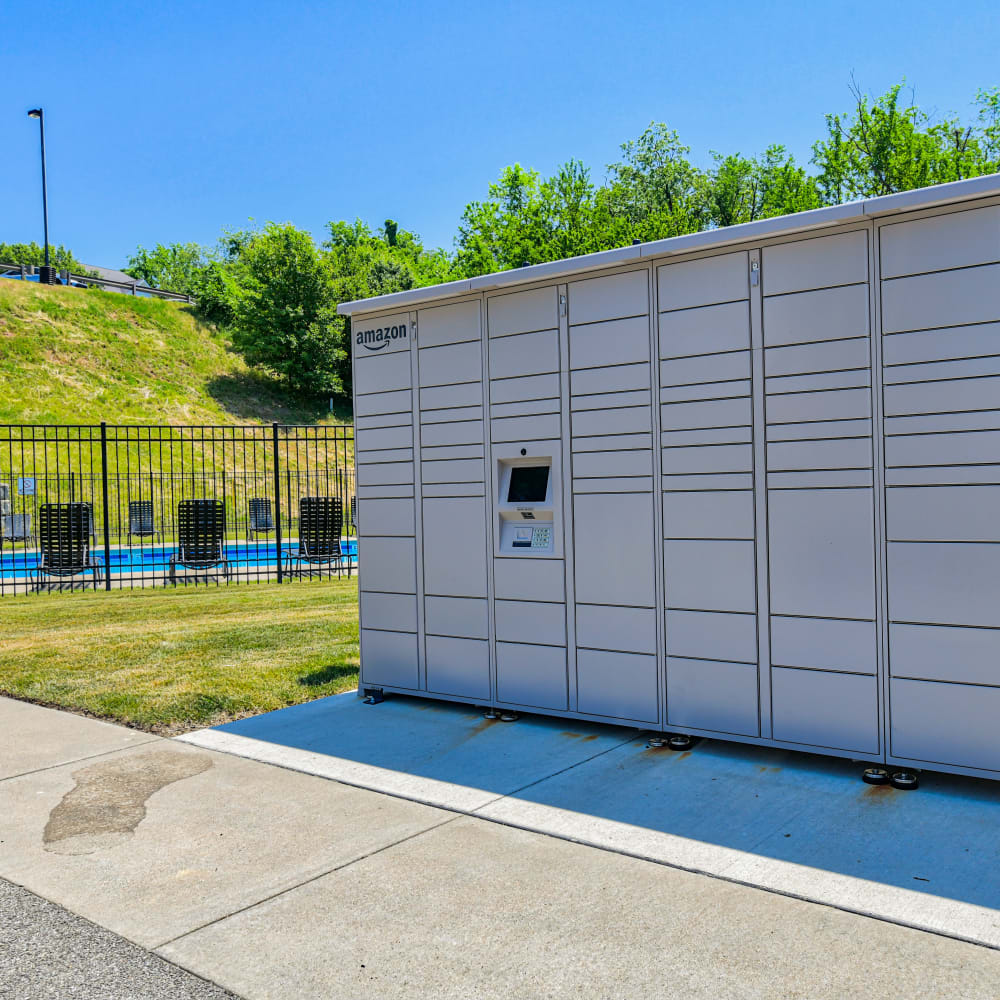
[337,173,1000,316]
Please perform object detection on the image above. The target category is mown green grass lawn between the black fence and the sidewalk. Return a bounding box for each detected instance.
[0,578,359,734]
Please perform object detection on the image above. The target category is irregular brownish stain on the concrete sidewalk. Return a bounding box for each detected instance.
[42,750,212,854]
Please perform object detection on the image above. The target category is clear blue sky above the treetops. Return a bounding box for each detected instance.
[0,0,1000,266]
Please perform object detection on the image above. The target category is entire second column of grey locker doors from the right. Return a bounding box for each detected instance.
[762,230,882,756]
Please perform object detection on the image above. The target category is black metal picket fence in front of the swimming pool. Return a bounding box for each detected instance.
[0,424,357,595]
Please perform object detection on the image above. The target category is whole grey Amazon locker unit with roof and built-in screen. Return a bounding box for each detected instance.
[340,175,1000,777]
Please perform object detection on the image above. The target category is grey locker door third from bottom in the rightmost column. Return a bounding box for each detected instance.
[889,542,1000,628]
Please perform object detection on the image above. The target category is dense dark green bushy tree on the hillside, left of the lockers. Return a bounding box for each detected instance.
[227,222,348,395]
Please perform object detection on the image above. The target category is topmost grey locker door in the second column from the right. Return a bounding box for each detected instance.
[761,230,868,295]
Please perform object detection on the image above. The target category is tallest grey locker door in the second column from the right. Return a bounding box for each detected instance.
[768,489,875,619]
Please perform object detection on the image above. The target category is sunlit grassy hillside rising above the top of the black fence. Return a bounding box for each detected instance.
[0,280,350,424]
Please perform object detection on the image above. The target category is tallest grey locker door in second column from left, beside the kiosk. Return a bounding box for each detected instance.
[423,495,486,597]
